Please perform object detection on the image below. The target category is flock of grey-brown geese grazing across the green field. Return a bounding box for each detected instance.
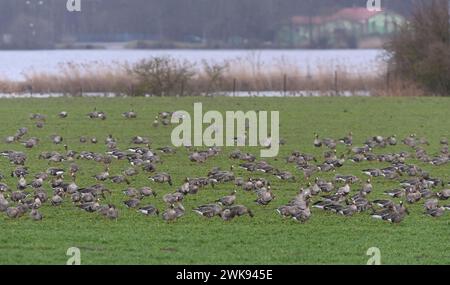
[0,110,450,223]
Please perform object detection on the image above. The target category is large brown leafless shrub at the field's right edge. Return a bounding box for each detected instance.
[387,0,450,95]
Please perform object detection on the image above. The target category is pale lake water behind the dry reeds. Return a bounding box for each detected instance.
[0,50,383,80]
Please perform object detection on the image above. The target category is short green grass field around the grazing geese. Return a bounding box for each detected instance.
[0,98,450,264]
